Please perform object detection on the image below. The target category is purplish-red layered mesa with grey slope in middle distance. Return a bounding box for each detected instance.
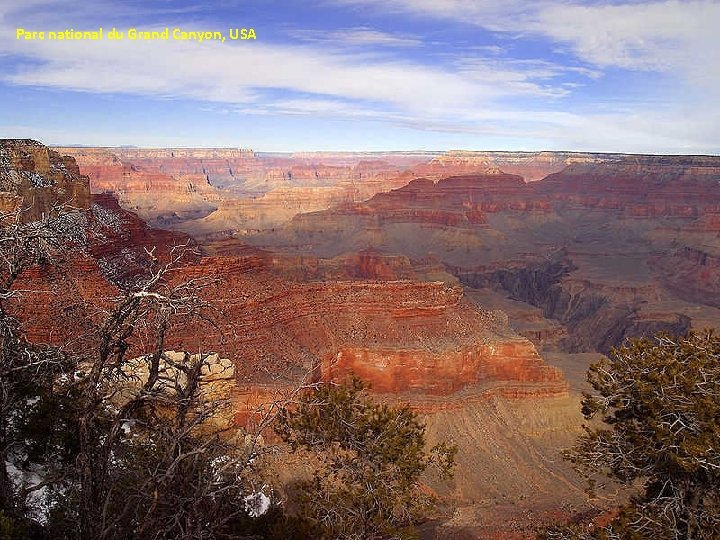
[243,172,555,265]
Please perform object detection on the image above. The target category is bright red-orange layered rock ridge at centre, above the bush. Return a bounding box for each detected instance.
[159,268,566,395]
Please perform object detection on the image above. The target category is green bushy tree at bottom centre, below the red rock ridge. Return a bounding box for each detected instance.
[276,378,456,539]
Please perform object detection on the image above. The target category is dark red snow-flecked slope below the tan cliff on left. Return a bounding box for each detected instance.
[7,191,197,349]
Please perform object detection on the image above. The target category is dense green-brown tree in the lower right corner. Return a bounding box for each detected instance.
[567,331,720,539]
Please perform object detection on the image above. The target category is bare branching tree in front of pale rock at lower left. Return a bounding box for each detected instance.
[29,246,262,538]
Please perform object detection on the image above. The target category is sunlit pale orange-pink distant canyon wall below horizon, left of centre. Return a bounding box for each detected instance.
[59,148,427,237]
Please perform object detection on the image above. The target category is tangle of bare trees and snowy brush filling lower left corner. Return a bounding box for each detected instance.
[0,200,328,539]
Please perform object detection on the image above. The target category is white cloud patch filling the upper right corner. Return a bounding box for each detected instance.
[337,0,720,85]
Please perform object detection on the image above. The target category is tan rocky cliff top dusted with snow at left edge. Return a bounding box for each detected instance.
[0,139,90,220]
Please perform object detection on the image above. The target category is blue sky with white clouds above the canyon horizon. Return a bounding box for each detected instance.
[0,0,720,154]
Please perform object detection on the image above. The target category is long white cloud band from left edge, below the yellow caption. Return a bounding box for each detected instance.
[4,37,480,110]
